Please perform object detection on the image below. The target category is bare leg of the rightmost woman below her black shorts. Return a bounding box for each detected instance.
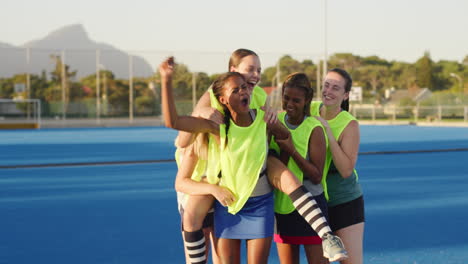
[335,223,364,264]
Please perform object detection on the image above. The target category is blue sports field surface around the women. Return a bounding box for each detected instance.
[0,126,468,264]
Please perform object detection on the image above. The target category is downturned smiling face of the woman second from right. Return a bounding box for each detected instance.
[283,87,310,125]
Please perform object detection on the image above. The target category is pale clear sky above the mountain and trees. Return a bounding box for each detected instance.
[0,0,468,71]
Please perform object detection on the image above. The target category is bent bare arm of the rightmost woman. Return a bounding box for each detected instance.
[316,117,359,178]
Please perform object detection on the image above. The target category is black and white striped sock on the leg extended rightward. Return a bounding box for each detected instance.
[289,185,331,238]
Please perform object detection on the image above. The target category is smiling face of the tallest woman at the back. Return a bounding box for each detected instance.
[229,55,262,91]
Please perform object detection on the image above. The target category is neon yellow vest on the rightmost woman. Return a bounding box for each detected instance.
[310,101,357,200]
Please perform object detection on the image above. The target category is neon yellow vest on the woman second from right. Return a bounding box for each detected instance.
[270,112,323,214]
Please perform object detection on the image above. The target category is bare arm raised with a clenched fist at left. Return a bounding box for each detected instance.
[159,57,219,135]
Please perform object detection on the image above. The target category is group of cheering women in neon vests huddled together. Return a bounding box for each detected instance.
[159,49,364,263]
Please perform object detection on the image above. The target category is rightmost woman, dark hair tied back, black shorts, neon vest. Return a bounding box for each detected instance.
[311,68,365,264]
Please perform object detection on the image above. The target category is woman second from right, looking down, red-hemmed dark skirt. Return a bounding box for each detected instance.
[270,73,328,264]
